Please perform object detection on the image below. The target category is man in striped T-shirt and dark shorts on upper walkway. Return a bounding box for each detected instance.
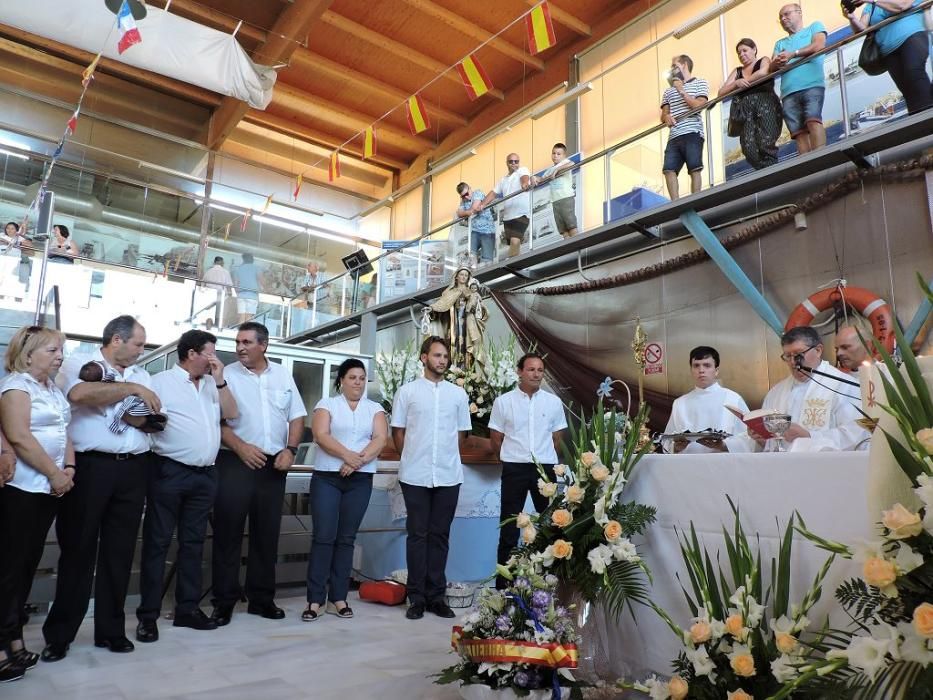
[661,55,709,200]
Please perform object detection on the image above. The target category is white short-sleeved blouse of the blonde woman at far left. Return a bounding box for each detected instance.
[0,372,71,493]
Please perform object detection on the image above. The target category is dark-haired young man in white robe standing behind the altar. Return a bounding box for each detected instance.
[664,345,748,452]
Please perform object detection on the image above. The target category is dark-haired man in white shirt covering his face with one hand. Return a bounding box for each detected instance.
[136,330,237,642]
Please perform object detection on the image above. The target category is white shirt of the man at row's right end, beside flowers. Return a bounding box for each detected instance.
[489,387,567,464]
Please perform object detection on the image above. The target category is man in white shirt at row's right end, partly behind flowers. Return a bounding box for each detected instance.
[489,352,567,589]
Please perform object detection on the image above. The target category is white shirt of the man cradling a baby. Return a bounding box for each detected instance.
[56,348,152,454]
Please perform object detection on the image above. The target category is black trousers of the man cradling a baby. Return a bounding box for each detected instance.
[42,452,149,644]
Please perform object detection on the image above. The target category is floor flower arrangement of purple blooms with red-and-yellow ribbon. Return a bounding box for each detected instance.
[436,559,580,700]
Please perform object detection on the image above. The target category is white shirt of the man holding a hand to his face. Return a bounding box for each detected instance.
[152,365,220,467]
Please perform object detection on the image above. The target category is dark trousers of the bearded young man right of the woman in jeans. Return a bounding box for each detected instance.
[401,482,460,604]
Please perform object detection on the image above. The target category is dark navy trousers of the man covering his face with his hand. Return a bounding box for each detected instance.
[136,456,217,621]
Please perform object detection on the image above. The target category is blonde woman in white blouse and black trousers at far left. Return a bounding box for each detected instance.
[0,326,74,681]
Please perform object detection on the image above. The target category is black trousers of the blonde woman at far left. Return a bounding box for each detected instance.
[0,484,58,649]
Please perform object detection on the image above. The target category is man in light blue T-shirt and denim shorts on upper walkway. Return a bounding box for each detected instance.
[770,3,826,153]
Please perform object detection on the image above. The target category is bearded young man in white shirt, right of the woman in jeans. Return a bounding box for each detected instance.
[392,335,471,620]
